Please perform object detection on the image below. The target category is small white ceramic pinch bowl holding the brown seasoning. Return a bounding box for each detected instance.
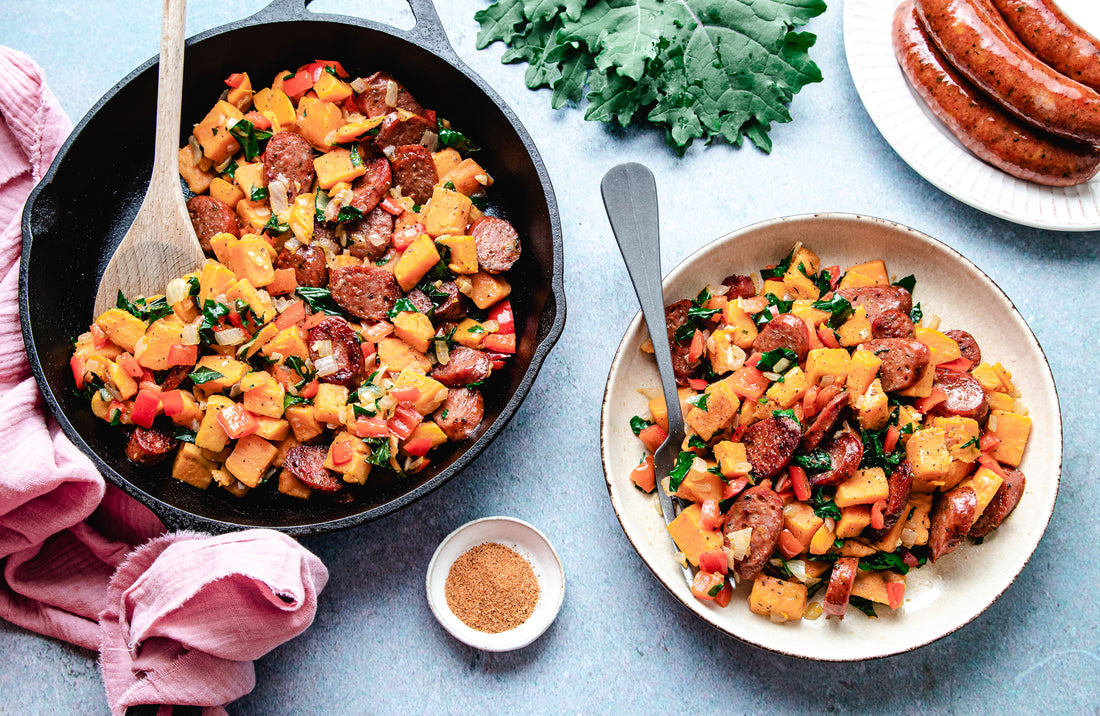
[427,517,565,651]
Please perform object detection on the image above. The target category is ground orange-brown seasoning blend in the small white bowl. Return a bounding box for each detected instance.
[443,542,539,634]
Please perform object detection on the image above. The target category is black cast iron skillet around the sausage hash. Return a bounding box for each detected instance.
[20,0,565,535]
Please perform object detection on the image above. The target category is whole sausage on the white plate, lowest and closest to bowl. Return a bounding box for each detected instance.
[893,2,1100,186]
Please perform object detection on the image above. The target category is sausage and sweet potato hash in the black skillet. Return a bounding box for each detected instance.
[72,60,520,500]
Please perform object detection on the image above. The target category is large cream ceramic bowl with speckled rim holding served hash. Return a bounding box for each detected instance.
[601,213,1062,661]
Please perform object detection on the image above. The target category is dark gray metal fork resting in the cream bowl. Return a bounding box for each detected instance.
[600,164,692,585]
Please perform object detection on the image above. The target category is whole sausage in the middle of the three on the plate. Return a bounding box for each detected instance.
[916,0,1100,143]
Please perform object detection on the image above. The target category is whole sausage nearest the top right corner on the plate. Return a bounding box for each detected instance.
[990,0,1100,91]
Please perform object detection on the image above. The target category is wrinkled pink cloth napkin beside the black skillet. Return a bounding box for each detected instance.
[0,46,328,714]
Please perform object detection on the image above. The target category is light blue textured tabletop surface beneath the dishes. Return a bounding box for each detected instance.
[0,0,1100,714]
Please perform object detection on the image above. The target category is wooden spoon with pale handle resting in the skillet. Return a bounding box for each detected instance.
[94,0,206,316]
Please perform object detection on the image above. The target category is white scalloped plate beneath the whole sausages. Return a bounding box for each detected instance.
[844,0,1100,231]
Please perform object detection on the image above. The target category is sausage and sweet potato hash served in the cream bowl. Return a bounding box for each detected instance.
[631,244,1031,621]
